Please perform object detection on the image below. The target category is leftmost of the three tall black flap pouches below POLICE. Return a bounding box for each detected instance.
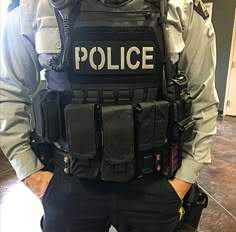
[65,104,100,179]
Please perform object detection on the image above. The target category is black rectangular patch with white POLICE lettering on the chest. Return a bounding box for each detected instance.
[73,41,157,74]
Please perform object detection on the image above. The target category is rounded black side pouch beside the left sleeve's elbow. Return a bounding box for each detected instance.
[32,89,61,143]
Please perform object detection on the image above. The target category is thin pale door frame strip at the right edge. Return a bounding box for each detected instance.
[223,8,236,116]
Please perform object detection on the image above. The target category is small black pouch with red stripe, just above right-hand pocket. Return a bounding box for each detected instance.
[161,144,182,178]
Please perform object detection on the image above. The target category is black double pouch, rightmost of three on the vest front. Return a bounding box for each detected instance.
[135,101,169,175]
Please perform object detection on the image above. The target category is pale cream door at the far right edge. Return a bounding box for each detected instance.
[226,11,236,116]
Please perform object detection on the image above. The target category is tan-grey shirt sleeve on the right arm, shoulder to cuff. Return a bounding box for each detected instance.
[167,0,218,183]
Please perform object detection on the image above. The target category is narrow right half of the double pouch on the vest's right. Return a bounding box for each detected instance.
[153,101,169,149]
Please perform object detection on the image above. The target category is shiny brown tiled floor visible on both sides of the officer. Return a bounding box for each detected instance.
[0,117,236,232]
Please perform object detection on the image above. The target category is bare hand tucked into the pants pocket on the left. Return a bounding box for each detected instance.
[23,171,53,200]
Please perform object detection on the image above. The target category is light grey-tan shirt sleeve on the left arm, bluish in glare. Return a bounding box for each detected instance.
[0,6,43,180]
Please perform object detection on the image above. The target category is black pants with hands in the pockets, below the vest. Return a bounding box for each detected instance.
[42,171,181,232]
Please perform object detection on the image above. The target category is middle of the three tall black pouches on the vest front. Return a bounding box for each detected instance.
[101,105,135,182]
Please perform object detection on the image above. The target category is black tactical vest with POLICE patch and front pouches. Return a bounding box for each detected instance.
[34,0,194,182]
